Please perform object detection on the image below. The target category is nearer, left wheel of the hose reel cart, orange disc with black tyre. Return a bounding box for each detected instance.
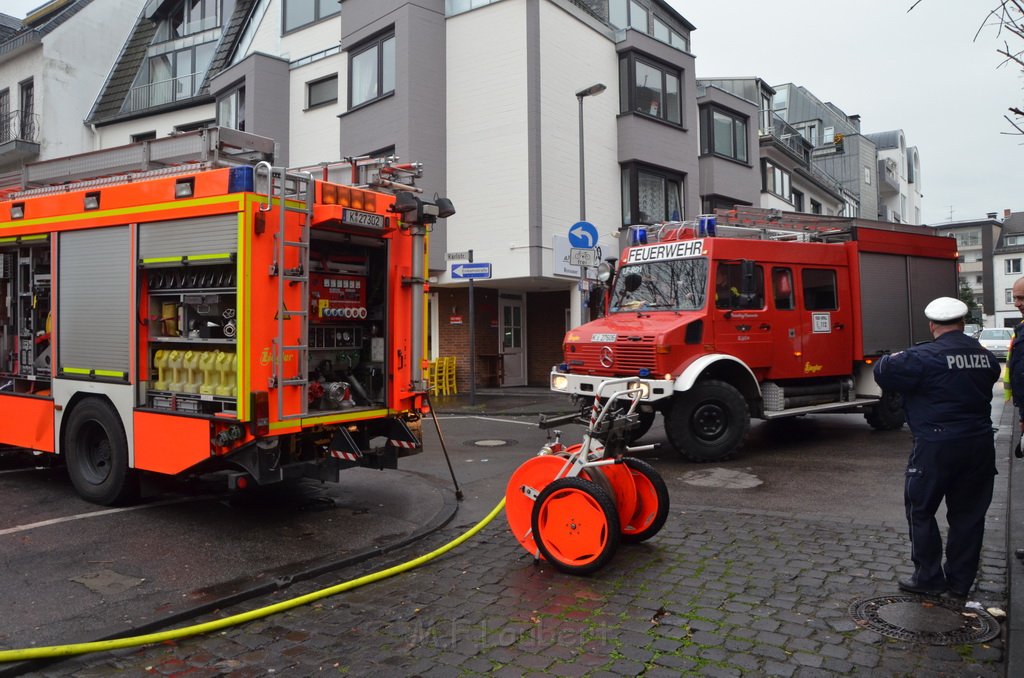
[531,477,620,575]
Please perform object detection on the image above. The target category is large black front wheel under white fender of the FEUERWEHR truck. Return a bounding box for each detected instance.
[665,380,751,462]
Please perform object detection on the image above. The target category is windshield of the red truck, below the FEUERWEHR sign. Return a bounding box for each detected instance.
[608,257,708,313]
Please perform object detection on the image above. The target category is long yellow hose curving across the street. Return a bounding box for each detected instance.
[0,498,505,663]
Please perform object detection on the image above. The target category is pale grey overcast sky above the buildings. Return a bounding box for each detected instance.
[0,0,1024,223]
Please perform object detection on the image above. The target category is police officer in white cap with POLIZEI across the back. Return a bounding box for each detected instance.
[874,297,999,599]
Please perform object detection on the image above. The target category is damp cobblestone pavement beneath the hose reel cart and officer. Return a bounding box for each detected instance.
[40,499,1006,677]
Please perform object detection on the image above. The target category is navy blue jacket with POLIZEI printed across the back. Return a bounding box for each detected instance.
[874,331,999,441]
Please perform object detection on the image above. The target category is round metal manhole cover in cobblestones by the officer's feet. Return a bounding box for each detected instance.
[850,595,999,645]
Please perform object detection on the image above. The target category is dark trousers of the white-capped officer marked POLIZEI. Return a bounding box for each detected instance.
[903,433,996,595]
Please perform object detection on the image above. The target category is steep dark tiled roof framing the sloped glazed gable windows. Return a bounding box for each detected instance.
[86,0,258,125]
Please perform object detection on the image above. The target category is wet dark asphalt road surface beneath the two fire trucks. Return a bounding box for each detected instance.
[0,401,1001,675]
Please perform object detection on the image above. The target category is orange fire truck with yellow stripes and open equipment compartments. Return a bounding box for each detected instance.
[0,129,454,504]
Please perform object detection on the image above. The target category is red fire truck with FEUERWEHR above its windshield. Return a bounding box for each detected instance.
[551,208,957,462]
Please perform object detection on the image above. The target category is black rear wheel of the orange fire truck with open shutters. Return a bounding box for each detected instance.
[65,397,138,506]
